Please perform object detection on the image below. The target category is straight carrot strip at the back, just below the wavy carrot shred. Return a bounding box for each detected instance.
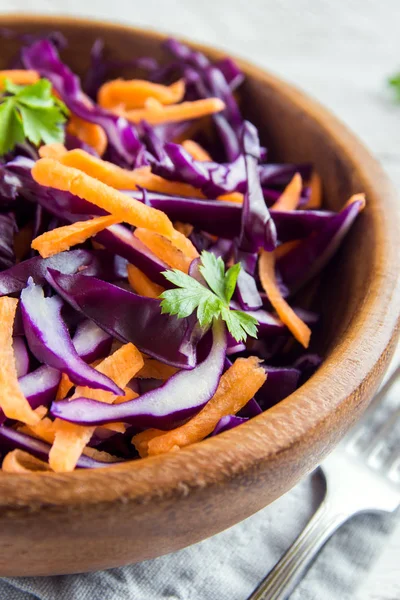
[118,98,225,125]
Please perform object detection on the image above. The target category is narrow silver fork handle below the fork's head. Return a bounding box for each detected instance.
[248,499,351,600]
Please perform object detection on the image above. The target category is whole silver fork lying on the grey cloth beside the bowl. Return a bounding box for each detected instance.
[248,367,400,600]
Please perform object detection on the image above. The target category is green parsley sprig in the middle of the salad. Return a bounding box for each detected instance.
[160,251,258,342]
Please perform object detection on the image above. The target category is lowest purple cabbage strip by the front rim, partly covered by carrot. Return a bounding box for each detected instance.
[0,425,116,469]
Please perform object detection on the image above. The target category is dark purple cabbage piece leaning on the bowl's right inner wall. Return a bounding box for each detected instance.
[277,200,362,294]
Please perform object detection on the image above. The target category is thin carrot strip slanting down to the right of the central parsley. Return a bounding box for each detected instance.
[258,250,311,348]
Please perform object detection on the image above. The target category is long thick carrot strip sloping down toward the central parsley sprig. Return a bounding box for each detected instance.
[32,158,174,235]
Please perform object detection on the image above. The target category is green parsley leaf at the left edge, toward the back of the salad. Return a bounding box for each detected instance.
[0,79,68,156]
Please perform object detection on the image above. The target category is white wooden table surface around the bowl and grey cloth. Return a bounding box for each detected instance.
[0,0,400,600]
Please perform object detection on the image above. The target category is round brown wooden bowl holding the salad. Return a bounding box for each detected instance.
[0,16,400,576]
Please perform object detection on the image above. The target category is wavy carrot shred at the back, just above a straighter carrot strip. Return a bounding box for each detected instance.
[97,79,185,110]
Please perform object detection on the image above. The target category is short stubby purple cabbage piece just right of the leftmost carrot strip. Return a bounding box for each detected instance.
[18,365,61,409]
